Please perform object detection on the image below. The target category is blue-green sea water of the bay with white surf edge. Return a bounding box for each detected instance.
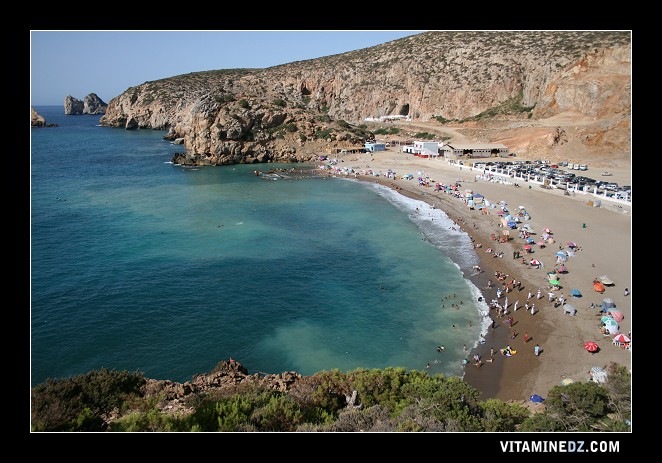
[30,106,486,385]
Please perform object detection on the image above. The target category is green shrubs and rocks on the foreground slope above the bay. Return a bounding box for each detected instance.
[32,362,631,431]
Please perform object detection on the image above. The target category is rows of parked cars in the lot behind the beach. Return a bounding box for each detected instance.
[473,161,632,199]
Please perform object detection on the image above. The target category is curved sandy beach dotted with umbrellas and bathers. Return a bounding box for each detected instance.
[320,150,632,400]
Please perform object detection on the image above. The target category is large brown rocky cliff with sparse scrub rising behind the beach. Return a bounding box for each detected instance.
[101,31,631,164]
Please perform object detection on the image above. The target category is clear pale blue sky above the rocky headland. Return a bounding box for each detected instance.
[30,31,422,106]
